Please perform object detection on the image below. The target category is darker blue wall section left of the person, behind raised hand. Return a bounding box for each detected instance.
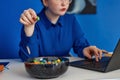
[0,0,42,58]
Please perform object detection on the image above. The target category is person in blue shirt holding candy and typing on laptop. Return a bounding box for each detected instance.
[19,0,106,61]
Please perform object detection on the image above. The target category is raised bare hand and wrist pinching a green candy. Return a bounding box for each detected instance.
[20,9,39,37]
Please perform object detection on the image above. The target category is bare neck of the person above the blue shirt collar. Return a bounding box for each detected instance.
[45,10,60,24]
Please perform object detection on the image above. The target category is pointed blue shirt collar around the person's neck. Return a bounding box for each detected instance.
[40,9,63,28]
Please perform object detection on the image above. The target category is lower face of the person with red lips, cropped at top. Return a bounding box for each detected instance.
[43,0,72,16]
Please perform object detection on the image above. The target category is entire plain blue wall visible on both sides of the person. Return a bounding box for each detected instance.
[0,0,120,58]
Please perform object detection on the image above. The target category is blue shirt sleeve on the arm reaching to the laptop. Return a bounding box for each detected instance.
[73,18,90,58]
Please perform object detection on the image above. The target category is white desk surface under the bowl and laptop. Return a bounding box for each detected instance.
[0,57,120,80]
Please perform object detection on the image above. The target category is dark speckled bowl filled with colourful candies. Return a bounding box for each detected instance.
[24,57,69,79]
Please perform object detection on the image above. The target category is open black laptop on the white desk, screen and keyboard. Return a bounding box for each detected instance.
[70,39,120,72]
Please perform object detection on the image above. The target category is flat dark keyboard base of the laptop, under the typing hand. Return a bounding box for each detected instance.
[70,57,110,71]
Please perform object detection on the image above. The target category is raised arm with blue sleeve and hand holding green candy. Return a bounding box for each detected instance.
[19,9,38,61]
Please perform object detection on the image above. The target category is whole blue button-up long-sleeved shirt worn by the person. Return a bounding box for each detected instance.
[19,9,89,61]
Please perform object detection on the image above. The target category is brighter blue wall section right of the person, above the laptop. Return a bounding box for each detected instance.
[77,0,120,51]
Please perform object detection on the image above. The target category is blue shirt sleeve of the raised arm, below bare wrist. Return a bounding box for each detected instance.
[19,26,39,61]
